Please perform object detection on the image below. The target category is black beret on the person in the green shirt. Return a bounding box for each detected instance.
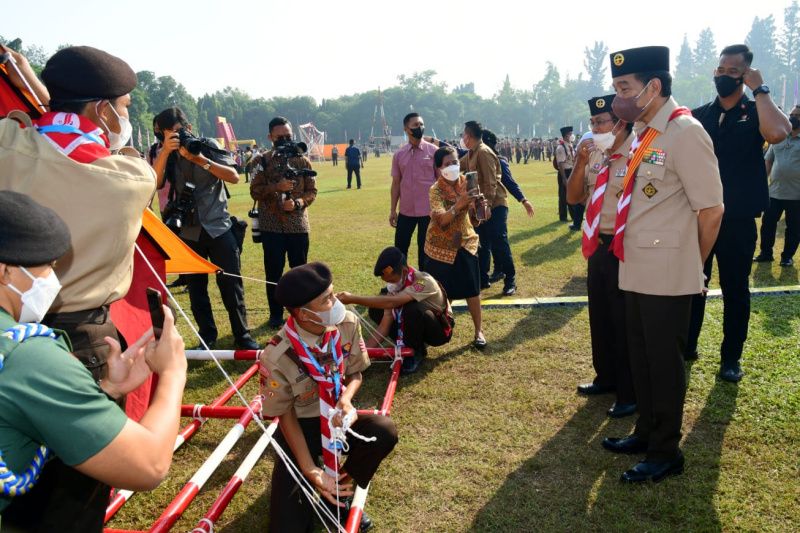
[0,191,70,266]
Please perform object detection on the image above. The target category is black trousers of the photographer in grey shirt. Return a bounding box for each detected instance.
[184,228,250,343]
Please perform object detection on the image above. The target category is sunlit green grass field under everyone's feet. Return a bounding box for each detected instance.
[109,157,800,532]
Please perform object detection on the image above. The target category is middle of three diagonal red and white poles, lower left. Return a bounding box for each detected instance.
[149,396,261,533]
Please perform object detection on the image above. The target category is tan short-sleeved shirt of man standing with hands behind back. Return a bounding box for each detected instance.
[619,98,722,296]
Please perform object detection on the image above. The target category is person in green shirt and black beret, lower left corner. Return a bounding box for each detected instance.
[0,191,186,533]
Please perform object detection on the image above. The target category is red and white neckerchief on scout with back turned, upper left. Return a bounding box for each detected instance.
[36,111,111,163]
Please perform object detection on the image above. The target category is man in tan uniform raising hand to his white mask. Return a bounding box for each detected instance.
[567,94,636,418]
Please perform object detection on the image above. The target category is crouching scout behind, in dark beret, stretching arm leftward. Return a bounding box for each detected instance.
[336,246,455,374]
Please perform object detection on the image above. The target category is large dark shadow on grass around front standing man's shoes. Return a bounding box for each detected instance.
[470,368,737,532]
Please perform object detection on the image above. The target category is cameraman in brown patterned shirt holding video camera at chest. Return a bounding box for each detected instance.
[250,117,317,329]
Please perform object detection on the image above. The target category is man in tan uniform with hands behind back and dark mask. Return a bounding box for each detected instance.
[603,46,724,482]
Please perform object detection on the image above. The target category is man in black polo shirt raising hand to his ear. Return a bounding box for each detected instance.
[685,44,791,383]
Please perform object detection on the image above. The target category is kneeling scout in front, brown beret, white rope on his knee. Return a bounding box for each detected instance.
[260,262,397,533]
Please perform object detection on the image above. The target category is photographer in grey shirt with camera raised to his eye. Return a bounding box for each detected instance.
[153,107,258,350]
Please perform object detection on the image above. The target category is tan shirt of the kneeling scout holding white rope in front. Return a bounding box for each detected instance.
[259,311,369,418]
